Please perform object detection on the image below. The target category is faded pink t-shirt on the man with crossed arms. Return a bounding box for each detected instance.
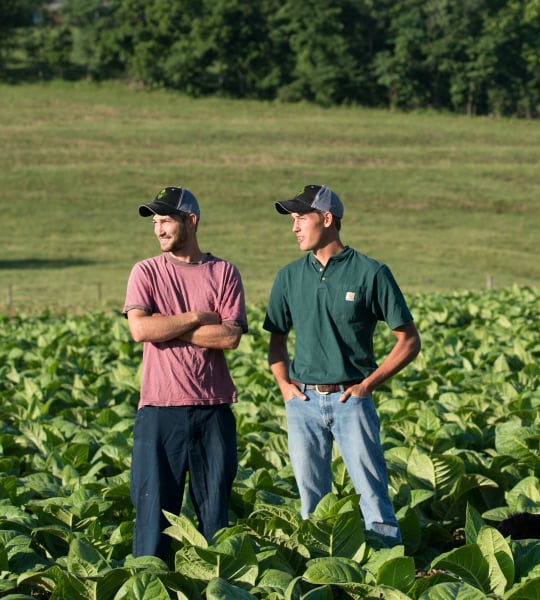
[123,254,247,408]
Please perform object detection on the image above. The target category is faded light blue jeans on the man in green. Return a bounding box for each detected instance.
[285,390,401,543]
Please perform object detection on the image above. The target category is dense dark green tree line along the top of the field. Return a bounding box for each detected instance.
[0,0,540,118]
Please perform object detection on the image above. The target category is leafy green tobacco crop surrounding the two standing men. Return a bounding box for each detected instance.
[0,287,540,600]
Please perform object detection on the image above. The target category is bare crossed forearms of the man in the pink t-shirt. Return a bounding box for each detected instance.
[127,308,243,350]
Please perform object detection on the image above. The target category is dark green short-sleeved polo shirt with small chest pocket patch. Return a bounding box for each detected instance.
[263,246,412,383]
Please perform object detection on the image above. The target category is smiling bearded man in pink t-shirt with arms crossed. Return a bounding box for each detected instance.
[123,187,247,560]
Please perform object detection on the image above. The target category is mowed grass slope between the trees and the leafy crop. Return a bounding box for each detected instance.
[0,83,540,308]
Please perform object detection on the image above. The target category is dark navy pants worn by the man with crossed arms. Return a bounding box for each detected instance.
[131,404,237,560]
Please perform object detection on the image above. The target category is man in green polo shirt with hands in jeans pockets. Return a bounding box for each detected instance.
[264,185,420,543]
